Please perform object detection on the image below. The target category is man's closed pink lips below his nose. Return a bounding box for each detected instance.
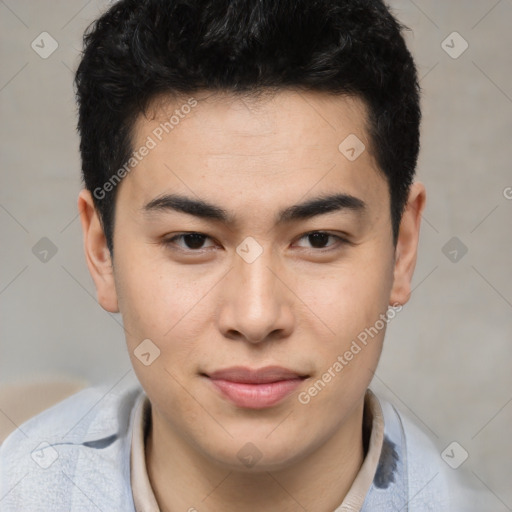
[206,366,307,409]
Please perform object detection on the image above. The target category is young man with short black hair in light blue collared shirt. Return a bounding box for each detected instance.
[0,0,480,512]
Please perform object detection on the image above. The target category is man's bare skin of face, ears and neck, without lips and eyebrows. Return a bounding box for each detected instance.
[78,90,425,512]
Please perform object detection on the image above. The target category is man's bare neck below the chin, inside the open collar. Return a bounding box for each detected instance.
[145,401,364,512]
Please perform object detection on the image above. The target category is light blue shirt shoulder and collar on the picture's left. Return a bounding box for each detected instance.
[0,378,143,512]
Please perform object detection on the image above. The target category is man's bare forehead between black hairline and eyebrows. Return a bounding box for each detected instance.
[119,90,387,220]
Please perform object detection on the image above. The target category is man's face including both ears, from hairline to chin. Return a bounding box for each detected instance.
[81,91,422,469]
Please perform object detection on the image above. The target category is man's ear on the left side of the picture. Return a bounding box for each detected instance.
[78,189,119,313]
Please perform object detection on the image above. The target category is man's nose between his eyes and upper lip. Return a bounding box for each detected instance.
[218,244,295,344]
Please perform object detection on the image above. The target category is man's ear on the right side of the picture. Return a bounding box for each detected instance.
[389,182,426,306]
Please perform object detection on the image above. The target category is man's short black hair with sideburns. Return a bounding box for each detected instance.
[75,0,421,254]
